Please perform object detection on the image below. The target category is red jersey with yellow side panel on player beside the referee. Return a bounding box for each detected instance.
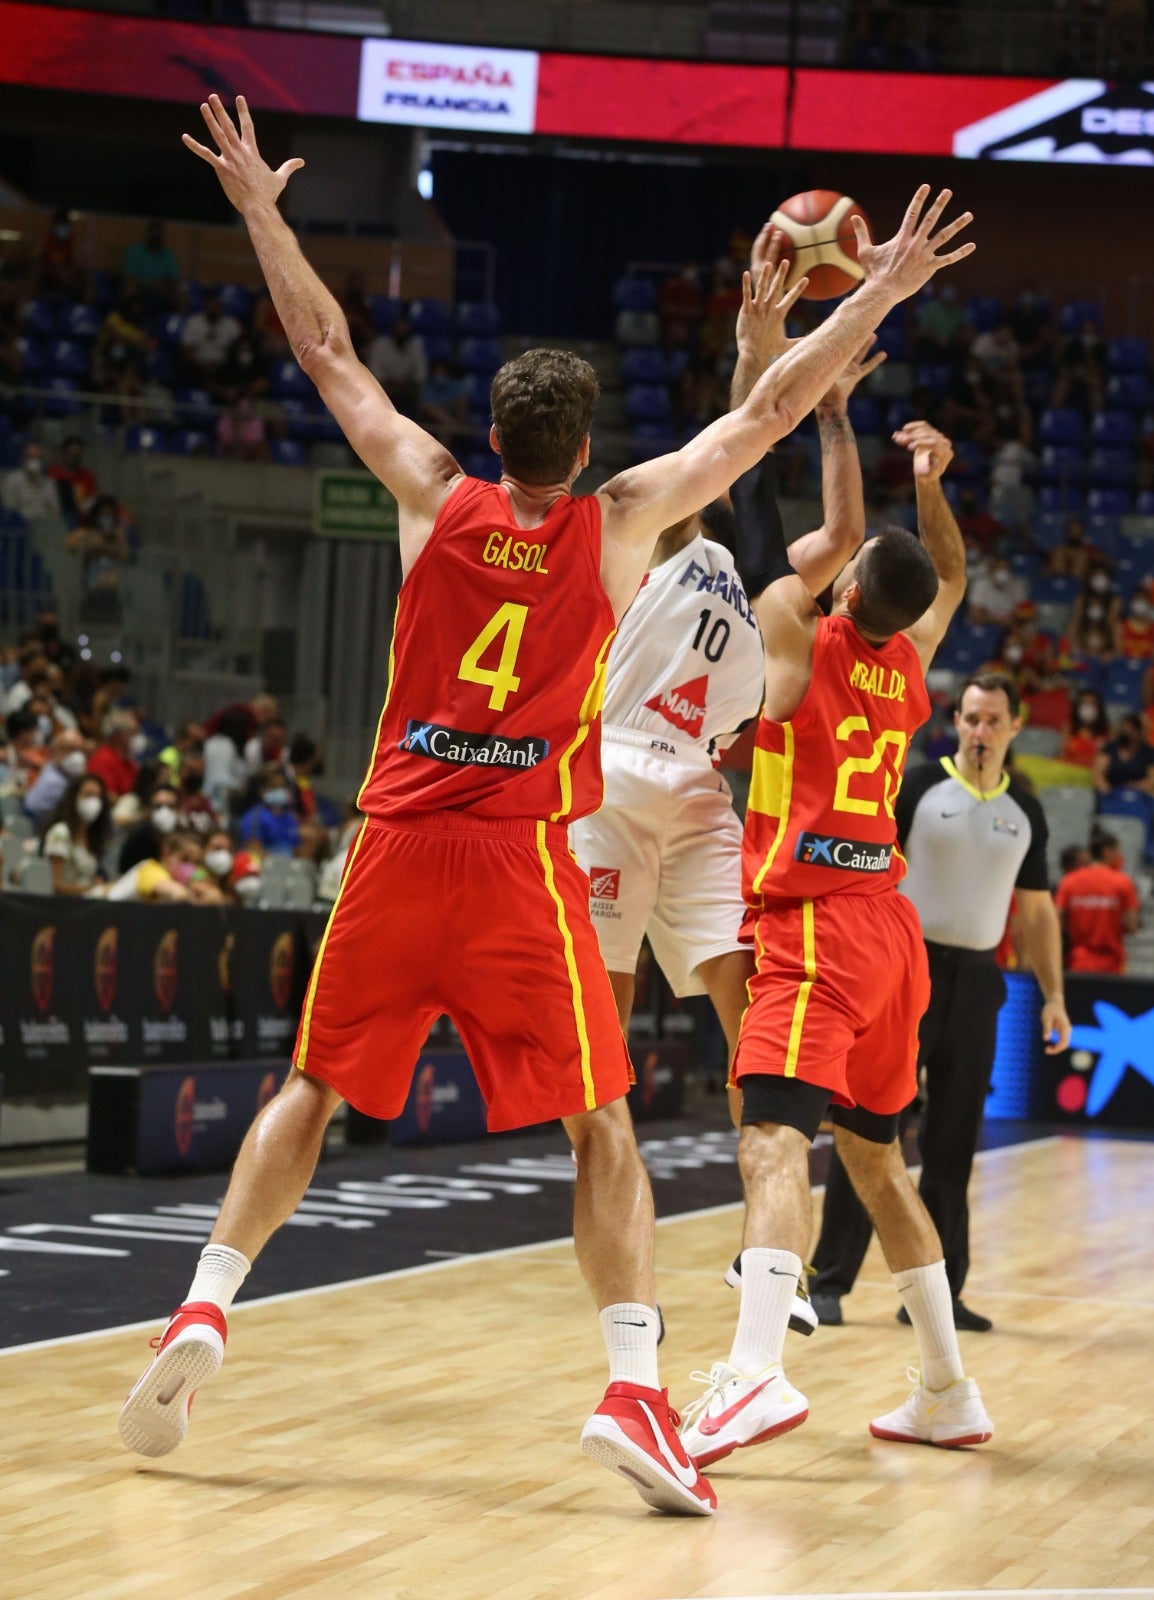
[741,616,930,910]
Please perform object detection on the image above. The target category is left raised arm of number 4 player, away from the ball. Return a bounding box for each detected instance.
[184,94,461,568]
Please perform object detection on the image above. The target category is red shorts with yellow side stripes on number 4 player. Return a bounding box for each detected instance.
[293,811,631,1131]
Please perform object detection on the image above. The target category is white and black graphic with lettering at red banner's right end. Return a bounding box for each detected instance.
[954,78,1154,166]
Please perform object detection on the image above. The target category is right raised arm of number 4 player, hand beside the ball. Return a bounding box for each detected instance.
[600,184,975,603]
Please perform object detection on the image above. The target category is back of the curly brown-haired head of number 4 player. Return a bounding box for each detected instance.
[488,350,600,483]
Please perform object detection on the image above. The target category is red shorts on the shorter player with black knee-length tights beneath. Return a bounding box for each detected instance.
[733,890,930,1115]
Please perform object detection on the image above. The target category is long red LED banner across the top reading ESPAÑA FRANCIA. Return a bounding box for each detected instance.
[0,0,1154,166]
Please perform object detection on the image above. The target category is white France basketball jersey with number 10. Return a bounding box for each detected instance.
[603,533,765,758]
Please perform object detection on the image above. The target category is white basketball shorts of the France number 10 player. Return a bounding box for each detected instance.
[570,728,747,997]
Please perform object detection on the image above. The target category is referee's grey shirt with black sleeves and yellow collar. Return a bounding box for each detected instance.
[895,755,1050,950]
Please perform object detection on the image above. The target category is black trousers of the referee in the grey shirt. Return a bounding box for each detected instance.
[811,939,1005,1299]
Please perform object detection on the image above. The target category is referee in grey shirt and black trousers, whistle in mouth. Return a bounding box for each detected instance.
[810,672,1069,1333]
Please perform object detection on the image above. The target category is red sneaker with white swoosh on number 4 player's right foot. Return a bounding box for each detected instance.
[581,1384,717,1517]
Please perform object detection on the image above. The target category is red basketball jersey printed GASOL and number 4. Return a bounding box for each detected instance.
[359,478,615,822]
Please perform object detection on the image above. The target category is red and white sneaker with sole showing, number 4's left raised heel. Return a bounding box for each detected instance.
[118,1301,229,1456]
